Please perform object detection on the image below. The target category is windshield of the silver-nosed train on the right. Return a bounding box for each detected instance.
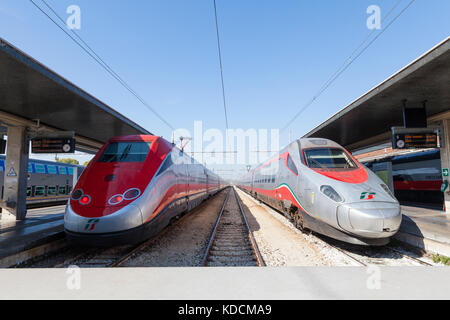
[303,148,358,169]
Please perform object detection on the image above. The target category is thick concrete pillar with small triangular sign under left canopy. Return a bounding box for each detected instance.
[2,127,29,220]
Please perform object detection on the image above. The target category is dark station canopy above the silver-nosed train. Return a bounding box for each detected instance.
[304,37,450,150]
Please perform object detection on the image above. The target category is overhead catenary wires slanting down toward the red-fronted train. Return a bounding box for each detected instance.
[29,0,175,130]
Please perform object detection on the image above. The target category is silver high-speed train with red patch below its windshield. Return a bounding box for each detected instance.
[239,138,401,245]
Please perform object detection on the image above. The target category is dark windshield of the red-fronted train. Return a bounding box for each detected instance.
[98,141,151,162]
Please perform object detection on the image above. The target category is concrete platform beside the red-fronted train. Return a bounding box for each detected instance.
[0,206,65,268]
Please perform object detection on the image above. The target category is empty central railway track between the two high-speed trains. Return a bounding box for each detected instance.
[202,187,265,266]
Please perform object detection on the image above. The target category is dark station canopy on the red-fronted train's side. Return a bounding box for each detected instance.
[0,38,151,150]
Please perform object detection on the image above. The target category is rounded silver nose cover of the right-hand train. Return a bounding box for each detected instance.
[337,202,402,238]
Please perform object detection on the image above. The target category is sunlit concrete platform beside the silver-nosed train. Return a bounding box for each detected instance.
[395,206,450,257]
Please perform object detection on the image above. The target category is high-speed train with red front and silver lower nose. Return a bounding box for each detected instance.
[64,135,225,246]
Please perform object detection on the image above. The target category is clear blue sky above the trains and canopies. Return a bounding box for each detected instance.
[0,0,450,178]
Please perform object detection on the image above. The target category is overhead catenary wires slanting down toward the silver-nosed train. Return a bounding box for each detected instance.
[281,0,415,131]
